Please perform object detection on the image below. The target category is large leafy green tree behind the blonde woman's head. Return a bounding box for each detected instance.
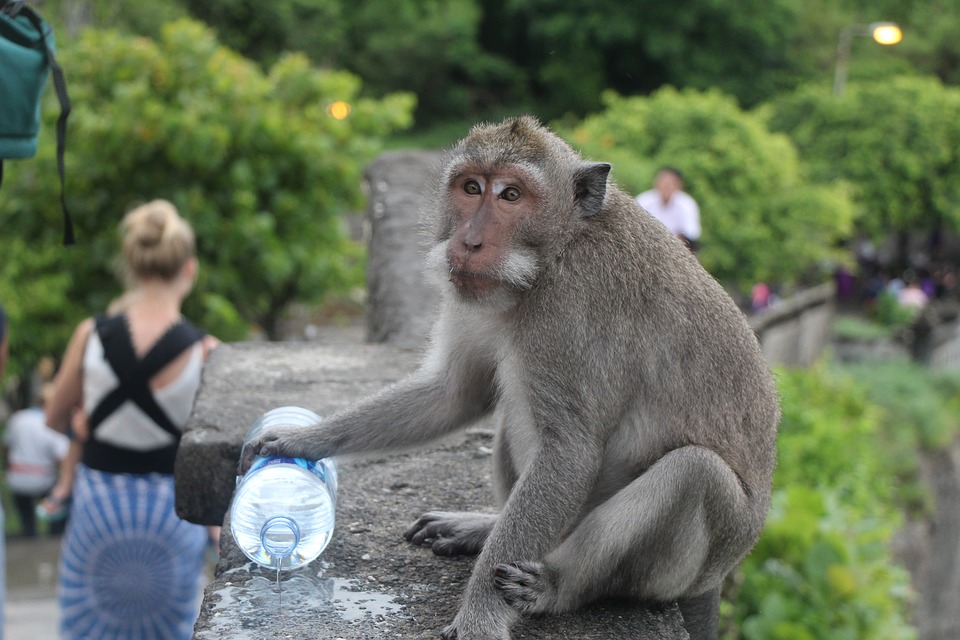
[0,20,413,380]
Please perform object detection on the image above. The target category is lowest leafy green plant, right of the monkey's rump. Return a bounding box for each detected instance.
[727,486,916,640]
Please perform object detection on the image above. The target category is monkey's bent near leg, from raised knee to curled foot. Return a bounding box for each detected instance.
[495,446,762,624]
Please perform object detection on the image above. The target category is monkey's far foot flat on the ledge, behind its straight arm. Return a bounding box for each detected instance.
[403,511,500,556]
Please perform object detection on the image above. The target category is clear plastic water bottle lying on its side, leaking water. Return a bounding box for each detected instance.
[230,407,337,571]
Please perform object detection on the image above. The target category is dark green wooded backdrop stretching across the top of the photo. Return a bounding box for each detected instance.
[28,0,960,135]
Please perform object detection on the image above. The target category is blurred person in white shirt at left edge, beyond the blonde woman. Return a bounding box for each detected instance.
[3,385,70,538]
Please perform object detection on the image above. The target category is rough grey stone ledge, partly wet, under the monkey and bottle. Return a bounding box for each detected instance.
[176,343,687,640]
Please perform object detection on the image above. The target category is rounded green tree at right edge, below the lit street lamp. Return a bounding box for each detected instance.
[764,77,960,239]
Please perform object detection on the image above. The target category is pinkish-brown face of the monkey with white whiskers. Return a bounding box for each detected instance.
[434,165,541,300]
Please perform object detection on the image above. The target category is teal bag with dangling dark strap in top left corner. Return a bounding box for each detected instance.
[0,0,74,244]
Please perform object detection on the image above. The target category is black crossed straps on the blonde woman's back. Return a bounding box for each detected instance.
[89,315,204,439]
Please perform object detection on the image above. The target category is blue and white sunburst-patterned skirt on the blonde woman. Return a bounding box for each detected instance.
[59,464,206,640]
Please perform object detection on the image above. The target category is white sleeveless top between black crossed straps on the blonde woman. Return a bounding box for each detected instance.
[83,330,203,451]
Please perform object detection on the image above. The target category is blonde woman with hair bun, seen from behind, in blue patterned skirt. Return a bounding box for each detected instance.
[47,200,217,640]
